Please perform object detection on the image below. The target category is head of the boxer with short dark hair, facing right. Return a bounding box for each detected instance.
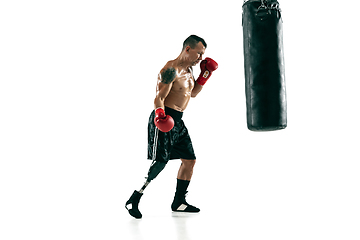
[182,35,207,66]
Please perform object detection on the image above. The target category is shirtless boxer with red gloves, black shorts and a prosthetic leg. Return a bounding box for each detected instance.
[125,35,218,218]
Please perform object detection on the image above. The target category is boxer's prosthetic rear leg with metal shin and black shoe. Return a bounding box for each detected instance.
[125,161,167,219]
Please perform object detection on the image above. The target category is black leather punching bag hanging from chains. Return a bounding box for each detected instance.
[242,0,287,131]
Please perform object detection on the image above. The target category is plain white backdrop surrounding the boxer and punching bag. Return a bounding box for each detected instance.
[0,0,360,240]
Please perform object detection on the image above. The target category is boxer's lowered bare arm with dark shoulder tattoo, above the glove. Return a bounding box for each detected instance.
[154,67,176,109]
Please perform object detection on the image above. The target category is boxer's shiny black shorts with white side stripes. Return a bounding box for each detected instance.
[148,107,196,162]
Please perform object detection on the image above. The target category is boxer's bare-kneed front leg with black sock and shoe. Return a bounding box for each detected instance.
[171,159,200,212]
